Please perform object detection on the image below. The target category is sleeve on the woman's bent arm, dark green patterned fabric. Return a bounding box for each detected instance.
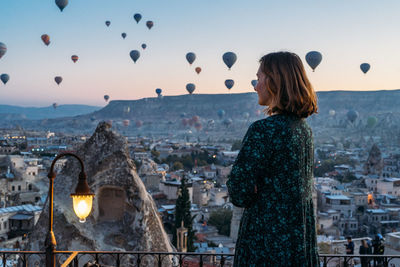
[226,122,267,208]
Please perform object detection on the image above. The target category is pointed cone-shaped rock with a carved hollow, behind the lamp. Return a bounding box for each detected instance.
[30,122,173,266]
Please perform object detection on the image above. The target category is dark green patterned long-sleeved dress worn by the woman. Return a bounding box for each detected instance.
[227,114,318,267]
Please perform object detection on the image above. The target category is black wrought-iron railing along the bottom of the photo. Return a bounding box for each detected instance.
[0,251,400,267]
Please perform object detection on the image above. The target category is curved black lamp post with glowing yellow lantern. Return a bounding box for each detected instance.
[45,153,94,267]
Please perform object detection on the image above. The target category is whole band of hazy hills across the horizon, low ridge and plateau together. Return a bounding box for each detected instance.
[0,90,400,136]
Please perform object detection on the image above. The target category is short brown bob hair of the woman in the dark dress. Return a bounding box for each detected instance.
[260,52,318,118]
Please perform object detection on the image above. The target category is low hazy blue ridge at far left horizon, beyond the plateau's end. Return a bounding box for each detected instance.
[0,105,101,120]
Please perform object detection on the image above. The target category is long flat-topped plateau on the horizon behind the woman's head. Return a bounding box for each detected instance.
[92,90,400,120]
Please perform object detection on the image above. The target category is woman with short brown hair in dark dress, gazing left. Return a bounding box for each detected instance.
[227,52,318,267]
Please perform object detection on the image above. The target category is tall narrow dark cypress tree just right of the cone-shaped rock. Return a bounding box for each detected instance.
[172,176,196,252]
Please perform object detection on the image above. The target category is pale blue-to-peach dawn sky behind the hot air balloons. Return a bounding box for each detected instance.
[0,0,400,106]
